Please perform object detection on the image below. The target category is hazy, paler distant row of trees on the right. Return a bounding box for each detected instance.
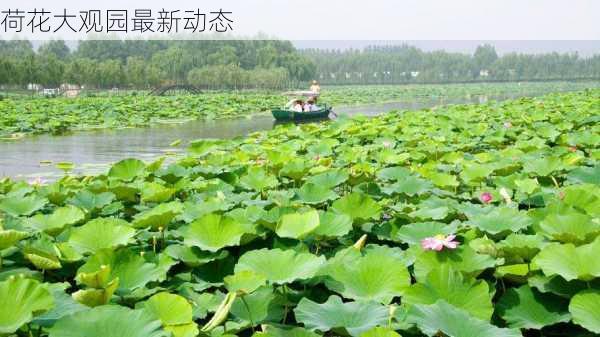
[302,45,600,84]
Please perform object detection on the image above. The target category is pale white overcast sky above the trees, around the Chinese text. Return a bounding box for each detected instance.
[0,0,600,51]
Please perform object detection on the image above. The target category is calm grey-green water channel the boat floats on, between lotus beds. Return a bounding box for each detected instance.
[0,95,552,179]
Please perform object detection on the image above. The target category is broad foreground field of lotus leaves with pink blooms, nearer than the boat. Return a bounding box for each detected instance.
[0,90,600,337]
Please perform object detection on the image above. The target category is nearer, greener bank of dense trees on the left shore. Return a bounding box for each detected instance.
[0,40,316,89]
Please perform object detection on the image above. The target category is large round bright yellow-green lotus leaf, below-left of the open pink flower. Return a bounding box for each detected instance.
[321,247,410,304]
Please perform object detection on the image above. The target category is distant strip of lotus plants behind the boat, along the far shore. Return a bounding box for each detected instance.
[0,82,600,140]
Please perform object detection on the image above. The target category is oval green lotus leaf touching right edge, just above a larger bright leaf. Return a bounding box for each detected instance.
[539,209,600,244]
